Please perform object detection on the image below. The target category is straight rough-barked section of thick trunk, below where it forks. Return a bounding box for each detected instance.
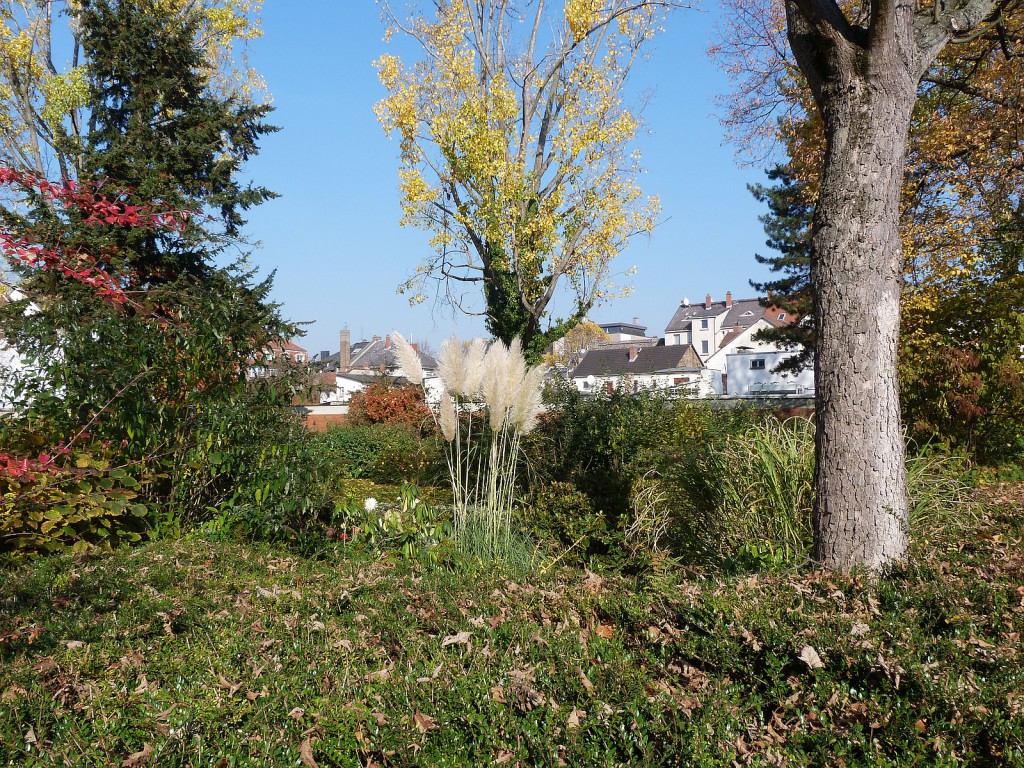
[812,70,916,571]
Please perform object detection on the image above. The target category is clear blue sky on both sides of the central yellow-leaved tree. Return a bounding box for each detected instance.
[247,0,767,352]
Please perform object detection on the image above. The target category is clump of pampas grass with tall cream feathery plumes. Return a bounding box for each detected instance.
[394,333,546,557]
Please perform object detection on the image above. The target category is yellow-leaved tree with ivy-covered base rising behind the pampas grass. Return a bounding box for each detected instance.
[377,0,672,355]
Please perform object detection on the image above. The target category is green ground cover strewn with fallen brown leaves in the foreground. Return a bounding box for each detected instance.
[0,495,1024,766]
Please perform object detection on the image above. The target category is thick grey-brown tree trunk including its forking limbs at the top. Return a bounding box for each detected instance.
[786,0,995,572]
